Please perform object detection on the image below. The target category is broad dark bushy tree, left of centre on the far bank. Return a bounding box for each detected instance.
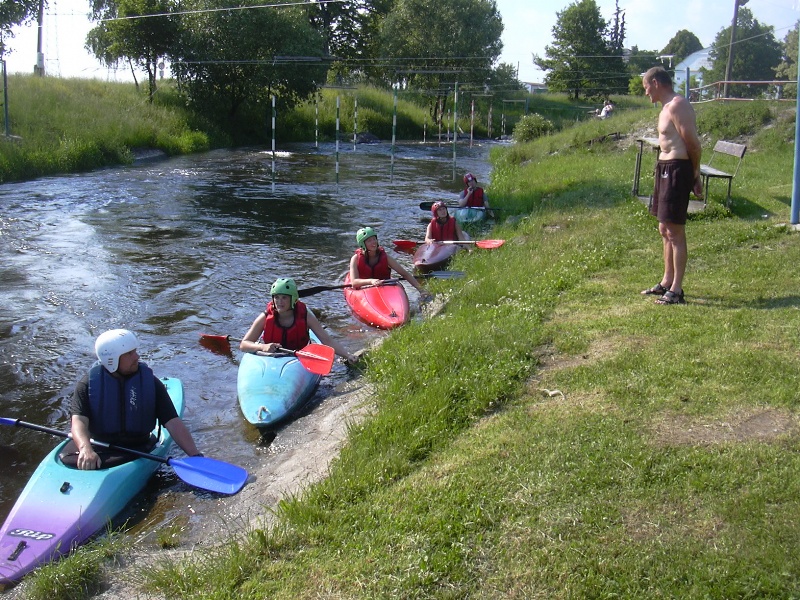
[169,0,328,121]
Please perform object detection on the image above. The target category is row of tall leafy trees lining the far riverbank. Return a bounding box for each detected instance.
[87,0,508,125]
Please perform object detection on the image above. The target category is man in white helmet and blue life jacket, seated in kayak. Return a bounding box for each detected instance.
[61,329,202,469]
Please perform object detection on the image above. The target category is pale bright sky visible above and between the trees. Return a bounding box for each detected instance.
[1,0,800,82]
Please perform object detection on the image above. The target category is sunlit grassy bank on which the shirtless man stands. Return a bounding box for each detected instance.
[18,90,800,599]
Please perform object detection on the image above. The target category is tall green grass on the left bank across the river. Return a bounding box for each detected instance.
[0,75,219,183]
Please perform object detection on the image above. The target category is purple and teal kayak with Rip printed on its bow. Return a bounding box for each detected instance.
[0,378,183,586]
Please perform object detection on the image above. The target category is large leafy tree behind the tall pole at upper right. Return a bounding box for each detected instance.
[703,7,782,98]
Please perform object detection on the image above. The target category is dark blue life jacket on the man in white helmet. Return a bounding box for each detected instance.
[89,362,156,441]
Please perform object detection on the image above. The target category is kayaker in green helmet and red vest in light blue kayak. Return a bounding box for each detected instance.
[239,278,358,363]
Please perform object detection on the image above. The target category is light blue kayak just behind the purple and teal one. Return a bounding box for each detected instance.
[236,332,320,427]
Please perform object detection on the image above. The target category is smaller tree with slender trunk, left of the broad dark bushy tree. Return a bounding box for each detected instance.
[86,0,178,102]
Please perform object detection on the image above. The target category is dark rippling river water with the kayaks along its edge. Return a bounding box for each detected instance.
[0,143,489,544]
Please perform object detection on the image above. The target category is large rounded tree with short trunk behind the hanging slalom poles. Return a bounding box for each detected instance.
[378,0,503,120]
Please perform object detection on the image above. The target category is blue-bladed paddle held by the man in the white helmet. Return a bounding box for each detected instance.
[0,417,247,494]
